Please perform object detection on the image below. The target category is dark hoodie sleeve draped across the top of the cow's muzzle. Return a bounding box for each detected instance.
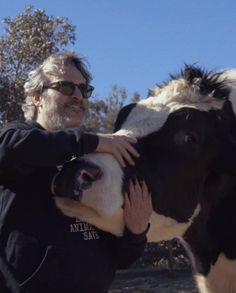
[0,123,98,168]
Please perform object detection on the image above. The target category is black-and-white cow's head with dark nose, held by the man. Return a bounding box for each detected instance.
[52,66,236,241]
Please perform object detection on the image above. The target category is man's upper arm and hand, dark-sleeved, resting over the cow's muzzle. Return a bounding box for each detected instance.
[0,123,138,168]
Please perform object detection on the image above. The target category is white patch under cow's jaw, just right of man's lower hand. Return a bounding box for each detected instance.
[147,204,201,242]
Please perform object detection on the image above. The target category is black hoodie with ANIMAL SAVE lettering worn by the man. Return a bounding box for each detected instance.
[0,121,146,293]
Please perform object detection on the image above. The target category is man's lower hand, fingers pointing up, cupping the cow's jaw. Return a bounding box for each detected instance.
[124,179,152,234]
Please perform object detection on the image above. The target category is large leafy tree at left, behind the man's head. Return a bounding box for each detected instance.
[0,6,76,122]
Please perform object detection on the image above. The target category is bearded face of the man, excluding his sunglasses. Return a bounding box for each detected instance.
[37,66,88,130]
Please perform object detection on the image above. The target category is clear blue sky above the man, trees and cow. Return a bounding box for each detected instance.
[0,0,236,98]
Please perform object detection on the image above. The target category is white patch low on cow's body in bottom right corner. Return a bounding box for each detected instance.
[195,253,236,293]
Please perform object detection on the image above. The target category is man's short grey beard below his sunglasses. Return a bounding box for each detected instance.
[43,100,86,130]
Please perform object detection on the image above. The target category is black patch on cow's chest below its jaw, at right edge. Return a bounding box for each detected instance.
[183,174,236,276]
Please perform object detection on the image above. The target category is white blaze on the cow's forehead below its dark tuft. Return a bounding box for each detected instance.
[116,78,224,138]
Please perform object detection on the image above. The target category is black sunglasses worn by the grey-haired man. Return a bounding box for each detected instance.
[43,80,94,99]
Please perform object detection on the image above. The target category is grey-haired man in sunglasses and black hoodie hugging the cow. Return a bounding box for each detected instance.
[0,52,152,293]
